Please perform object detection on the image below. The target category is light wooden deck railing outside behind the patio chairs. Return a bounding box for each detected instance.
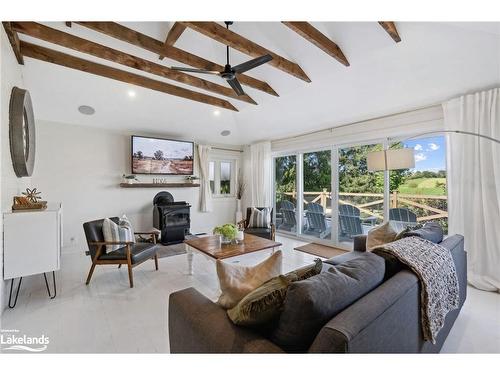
[283,189,448,222]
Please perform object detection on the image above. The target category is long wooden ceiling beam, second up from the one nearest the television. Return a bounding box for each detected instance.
[12,22,257,104]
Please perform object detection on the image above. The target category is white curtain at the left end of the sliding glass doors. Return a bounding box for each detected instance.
[246,142,272,207]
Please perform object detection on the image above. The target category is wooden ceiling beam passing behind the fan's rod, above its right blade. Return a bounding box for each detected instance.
[183,22,311,82]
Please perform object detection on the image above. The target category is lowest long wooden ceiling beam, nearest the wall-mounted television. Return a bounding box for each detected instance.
[21,41,238,111]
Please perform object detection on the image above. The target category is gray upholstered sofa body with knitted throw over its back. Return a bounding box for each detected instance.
[168,235,467,353]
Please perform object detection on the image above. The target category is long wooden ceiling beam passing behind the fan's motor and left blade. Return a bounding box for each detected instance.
[77,22,279,96]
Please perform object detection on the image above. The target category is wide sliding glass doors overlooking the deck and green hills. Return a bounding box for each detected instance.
[274,136,448,249]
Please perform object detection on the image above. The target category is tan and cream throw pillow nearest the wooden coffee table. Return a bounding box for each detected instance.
[216,250,283,309]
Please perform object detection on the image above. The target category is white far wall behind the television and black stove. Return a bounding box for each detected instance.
[32,121,240,251]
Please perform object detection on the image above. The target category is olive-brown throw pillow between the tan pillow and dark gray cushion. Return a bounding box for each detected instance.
[227,259,323,326]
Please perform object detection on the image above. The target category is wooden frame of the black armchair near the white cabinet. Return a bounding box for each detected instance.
[85,232,158,288]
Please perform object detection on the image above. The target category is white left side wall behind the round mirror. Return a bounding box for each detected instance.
[0,27,31,315]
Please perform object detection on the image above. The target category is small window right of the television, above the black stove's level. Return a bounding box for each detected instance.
[208,160,236,197]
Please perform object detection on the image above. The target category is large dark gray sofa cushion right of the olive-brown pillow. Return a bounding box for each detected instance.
[271,253,384,352]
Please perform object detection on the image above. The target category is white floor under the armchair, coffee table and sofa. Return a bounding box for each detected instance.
[1,237,500,353]
